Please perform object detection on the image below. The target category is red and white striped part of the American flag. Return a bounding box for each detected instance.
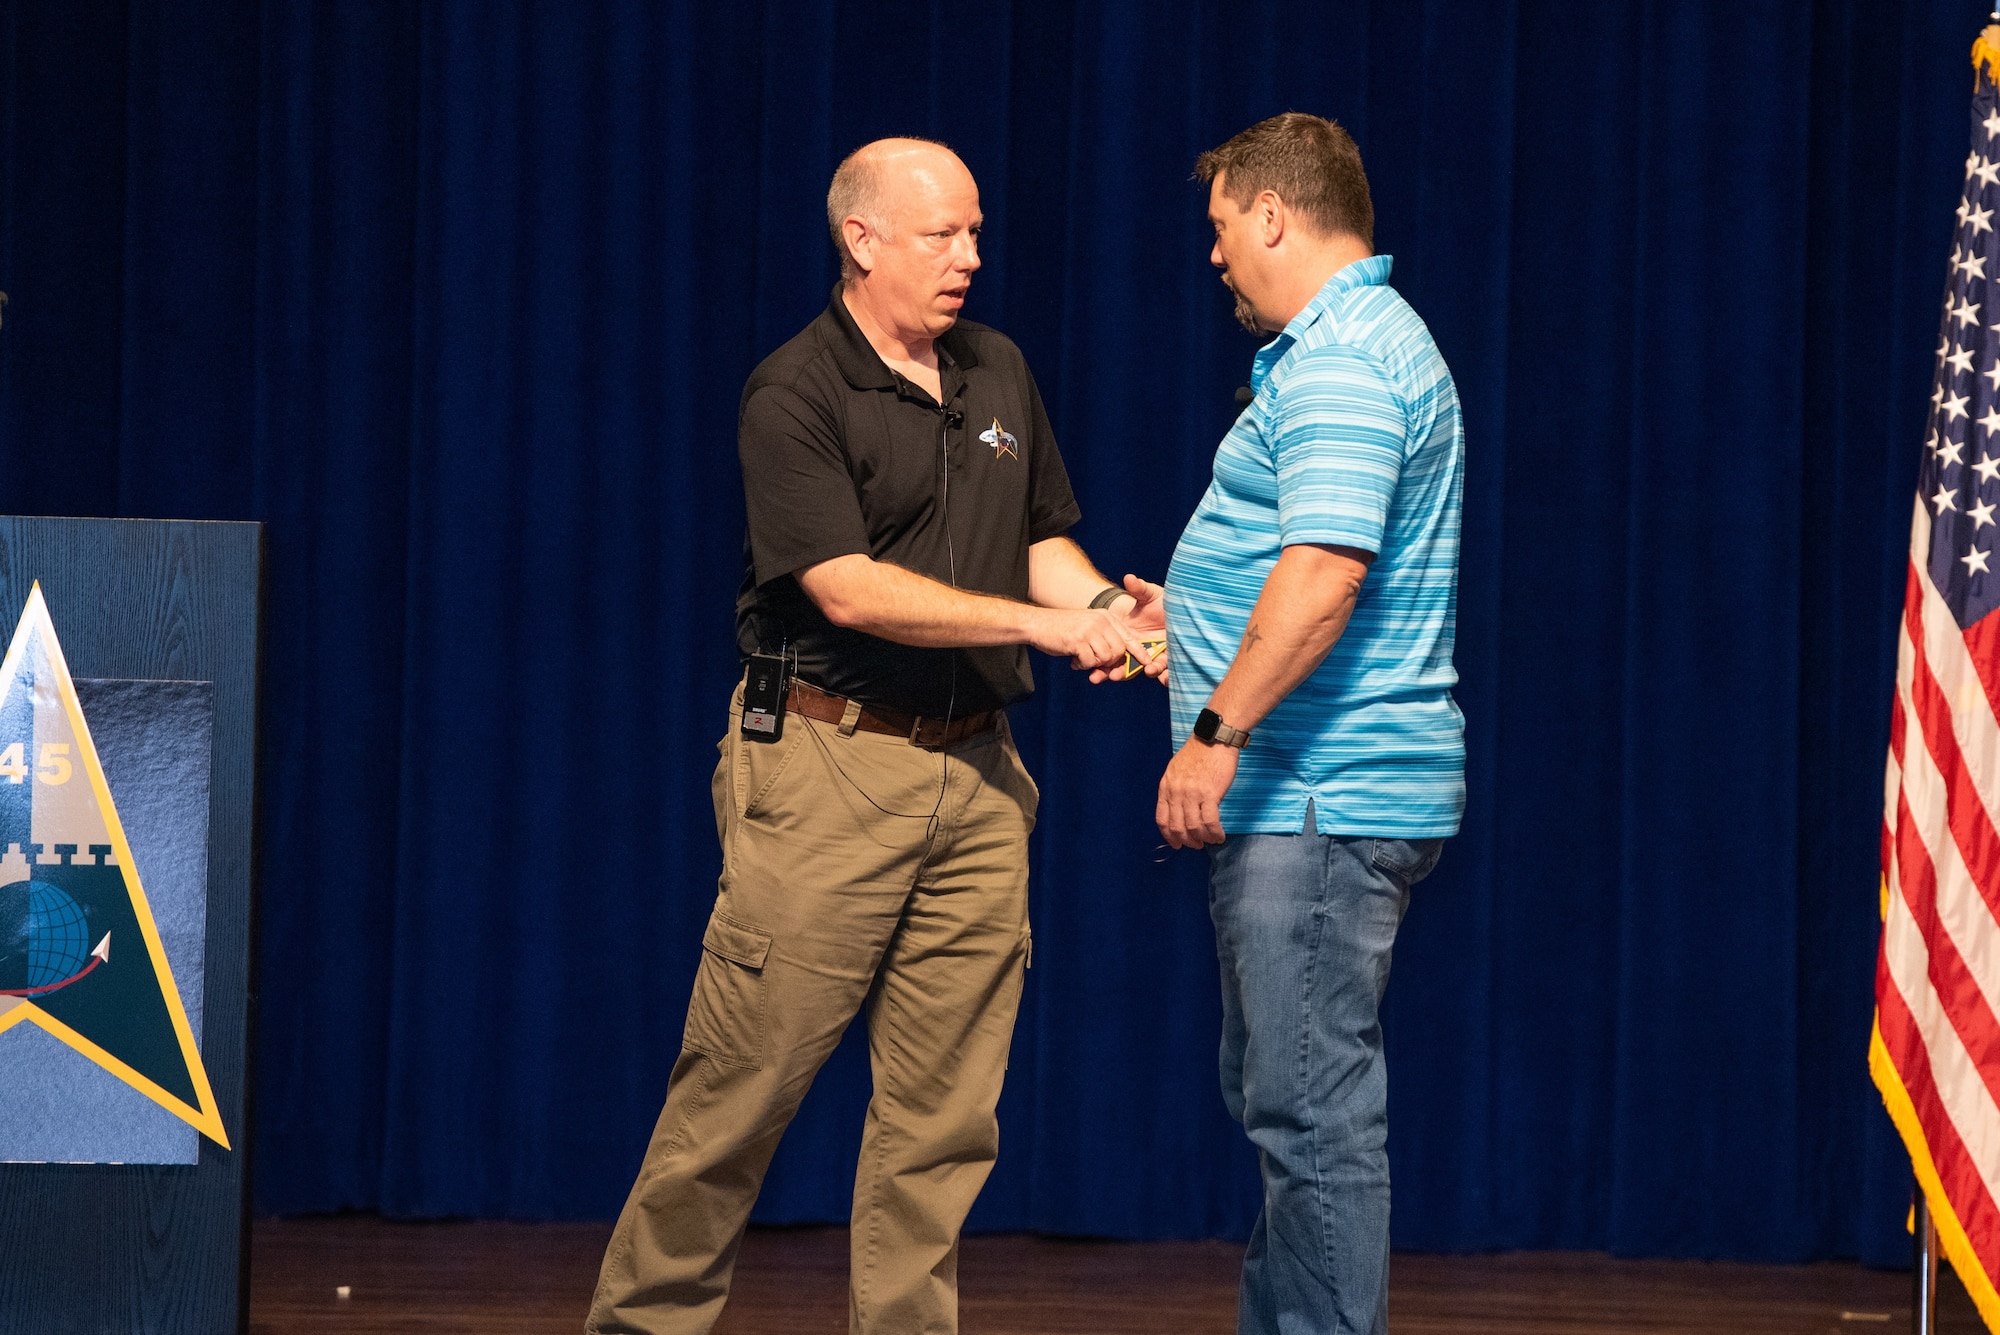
[1876,500,2000,1293]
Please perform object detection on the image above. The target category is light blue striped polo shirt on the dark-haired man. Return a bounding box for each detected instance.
[1166,256,1466,839]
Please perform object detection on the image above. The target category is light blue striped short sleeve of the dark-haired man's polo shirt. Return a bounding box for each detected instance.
[1272,346,1410,552]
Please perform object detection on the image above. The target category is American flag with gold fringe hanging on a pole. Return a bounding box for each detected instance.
[1868,26,2000,1331]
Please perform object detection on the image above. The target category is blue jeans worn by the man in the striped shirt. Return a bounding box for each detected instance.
[1208,805,1444,1335]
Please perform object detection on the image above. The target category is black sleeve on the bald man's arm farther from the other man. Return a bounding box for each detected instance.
[736,386,868,584]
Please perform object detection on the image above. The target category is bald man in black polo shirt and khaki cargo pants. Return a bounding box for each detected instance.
[586,140,1166,1335]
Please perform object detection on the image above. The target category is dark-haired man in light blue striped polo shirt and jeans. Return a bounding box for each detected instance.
[1158,114,1464,1335]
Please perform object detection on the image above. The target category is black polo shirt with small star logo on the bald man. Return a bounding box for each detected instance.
[736,286,1078,717]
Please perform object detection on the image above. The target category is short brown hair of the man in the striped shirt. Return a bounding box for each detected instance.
[1194,112,1374,250]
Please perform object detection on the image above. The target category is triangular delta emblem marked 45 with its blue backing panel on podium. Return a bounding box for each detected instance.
[0,584,228,1163]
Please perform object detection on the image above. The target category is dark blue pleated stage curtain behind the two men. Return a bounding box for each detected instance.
[0,0,1960,1261]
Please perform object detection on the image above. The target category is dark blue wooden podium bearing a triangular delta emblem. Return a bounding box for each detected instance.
[0,518,262,1335]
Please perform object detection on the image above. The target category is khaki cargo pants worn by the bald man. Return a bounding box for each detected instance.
[586,689,1036,1335]
